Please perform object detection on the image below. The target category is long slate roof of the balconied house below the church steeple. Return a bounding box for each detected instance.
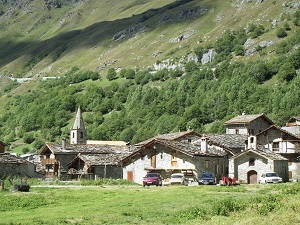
[41,143,130,155]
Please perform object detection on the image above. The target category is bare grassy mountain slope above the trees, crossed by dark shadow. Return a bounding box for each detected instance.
[0,0,292,77]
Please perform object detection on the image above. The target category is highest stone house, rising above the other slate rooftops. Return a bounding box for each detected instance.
[225,114,274,135]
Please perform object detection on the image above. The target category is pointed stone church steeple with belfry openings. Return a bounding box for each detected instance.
[70,107,87,144]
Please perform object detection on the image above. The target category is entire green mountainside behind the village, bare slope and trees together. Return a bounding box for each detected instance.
[0,0,300,152]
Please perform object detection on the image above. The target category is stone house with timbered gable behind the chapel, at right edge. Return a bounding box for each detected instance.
[256,125,300,180]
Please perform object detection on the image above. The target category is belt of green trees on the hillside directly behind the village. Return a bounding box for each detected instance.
[0,10,300,151]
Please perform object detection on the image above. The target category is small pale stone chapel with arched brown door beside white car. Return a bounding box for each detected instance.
[229,142,288,184]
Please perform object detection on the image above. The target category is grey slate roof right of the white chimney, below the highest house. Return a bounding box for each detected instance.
[205,134,248,149]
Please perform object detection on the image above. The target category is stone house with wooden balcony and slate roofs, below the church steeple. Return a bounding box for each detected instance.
[40,143,130,180]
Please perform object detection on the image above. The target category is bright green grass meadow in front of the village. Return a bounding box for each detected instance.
[0,183,300,225]
